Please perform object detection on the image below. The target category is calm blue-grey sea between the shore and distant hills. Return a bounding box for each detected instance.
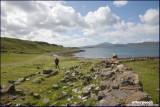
[75,46,159,58]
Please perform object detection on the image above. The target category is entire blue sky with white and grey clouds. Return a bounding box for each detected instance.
[1,1,159,47]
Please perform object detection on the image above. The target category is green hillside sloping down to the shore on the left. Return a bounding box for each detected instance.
[1,37,73,53]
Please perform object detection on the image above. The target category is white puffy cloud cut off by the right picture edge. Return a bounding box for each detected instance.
[139,8,159,25]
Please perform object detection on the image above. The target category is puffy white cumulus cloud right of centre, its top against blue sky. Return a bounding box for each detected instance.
[83,6,119,35]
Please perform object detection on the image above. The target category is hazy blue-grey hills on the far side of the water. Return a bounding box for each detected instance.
[81,42,159,48]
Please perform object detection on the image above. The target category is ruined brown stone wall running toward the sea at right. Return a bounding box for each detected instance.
[96,60,153,106]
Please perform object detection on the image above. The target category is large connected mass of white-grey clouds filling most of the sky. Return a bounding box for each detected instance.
[1,1,159,46]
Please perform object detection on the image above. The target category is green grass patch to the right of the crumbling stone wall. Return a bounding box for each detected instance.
[122,59,159,104]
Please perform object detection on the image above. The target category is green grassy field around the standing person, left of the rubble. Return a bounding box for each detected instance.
[1,53,99,106]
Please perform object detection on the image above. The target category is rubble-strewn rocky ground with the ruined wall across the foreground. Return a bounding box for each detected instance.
[1,58,159,106]
